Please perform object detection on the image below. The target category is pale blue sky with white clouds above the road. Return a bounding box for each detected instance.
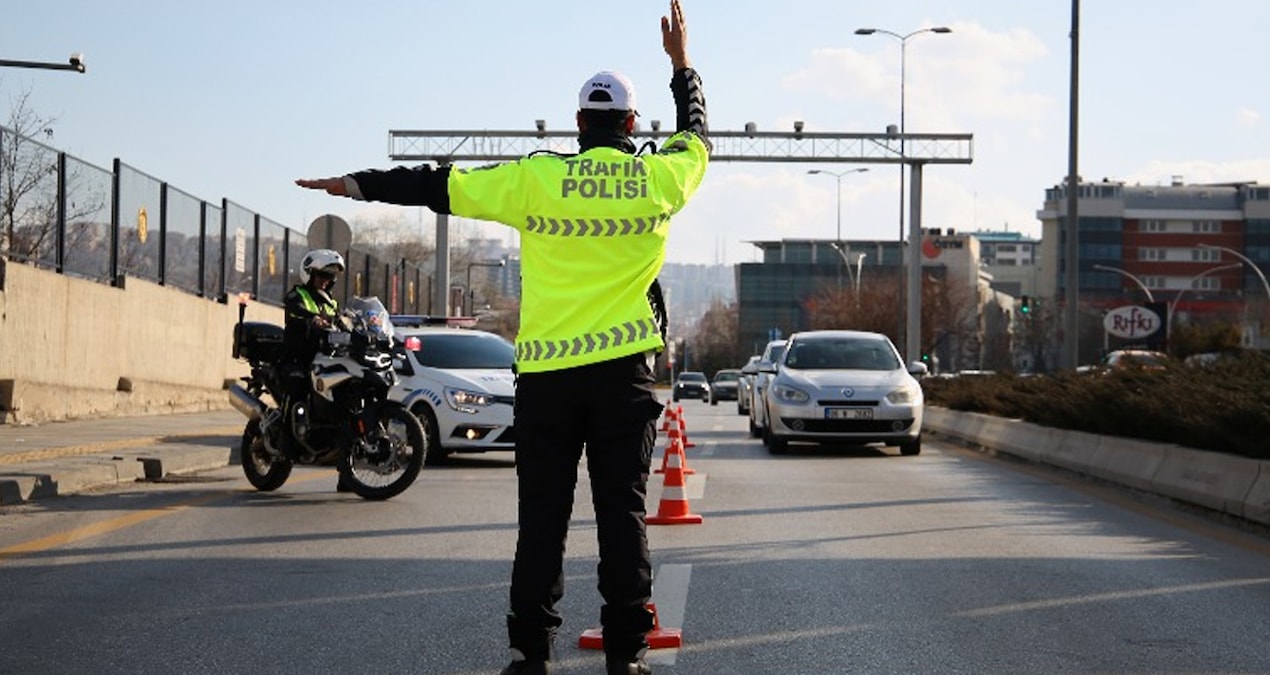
[0,0,1270,264]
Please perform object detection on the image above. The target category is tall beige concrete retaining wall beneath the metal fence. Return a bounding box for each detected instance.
[0,261,283,423]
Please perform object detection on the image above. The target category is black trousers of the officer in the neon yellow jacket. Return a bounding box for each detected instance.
[507,355,662,658]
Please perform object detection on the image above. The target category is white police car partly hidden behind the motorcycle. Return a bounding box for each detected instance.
[389,315,516,464]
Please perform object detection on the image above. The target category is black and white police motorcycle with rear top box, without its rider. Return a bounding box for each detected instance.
[229,297,427,500]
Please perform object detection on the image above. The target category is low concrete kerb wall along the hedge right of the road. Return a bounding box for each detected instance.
[923,407,1270,525]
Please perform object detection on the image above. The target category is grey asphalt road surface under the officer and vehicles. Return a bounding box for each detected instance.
[0,402,1270,675]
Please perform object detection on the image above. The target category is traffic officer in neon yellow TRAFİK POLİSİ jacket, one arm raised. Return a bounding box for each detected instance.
[296,0,710,675]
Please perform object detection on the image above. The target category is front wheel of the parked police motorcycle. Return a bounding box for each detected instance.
[339,400,427,500]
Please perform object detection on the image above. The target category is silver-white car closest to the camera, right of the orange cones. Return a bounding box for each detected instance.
[761,331,927,455]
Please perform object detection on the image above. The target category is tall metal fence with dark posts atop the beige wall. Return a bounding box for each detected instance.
[0,126,432,314]
